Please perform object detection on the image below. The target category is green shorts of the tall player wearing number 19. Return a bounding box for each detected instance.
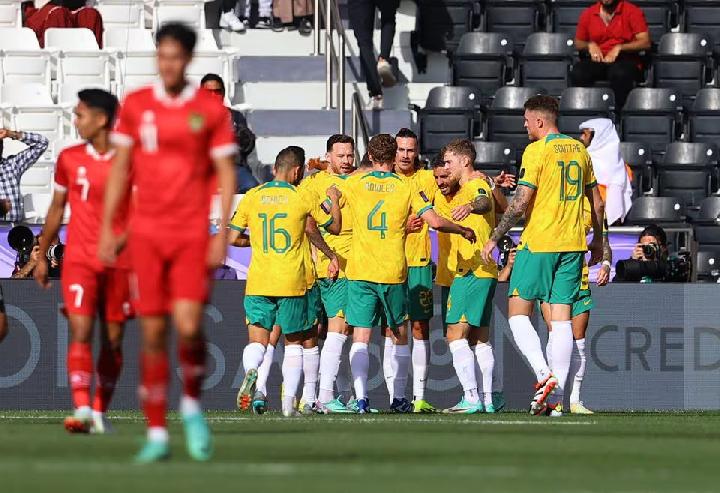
[508,249,585,305]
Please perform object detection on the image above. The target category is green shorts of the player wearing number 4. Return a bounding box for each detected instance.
[346,280,407,329]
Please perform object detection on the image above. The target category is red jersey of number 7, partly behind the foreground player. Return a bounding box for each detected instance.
[55,144,129,270]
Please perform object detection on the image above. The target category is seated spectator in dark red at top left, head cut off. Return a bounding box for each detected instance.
[23,0,103,48]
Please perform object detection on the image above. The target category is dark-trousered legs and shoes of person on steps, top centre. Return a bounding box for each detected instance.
[348,0,400,110]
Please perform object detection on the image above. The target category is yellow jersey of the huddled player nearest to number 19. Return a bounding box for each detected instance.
[449,178,497,278]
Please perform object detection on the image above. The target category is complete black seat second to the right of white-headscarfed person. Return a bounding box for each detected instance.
[658,142,718,207]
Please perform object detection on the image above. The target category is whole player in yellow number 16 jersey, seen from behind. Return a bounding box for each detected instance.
[230,148,342,416]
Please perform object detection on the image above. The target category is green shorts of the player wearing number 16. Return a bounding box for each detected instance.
[244,295,308,334]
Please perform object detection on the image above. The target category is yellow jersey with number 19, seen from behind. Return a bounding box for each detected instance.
[518,134,597,252]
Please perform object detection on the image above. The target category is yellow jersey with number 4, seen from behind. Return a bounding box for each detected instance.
[343,171,432,284]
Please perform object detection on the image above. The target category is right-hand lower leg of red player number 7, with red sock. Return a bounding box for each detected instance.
[90,322,124,433]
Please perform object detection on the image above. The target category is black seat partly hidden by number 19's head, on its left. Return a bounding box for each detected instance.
[484,86,543,162]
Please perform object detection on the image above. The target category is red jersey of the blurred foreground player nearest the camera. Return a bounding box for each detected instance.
[112,84,237,238]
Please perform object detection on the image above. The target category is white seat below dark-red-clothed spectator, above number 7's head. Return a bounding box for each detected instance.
[45,28,110,87]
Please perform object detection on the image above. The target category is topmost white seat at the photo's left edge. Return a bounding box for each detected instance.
[0,28,51,88]
